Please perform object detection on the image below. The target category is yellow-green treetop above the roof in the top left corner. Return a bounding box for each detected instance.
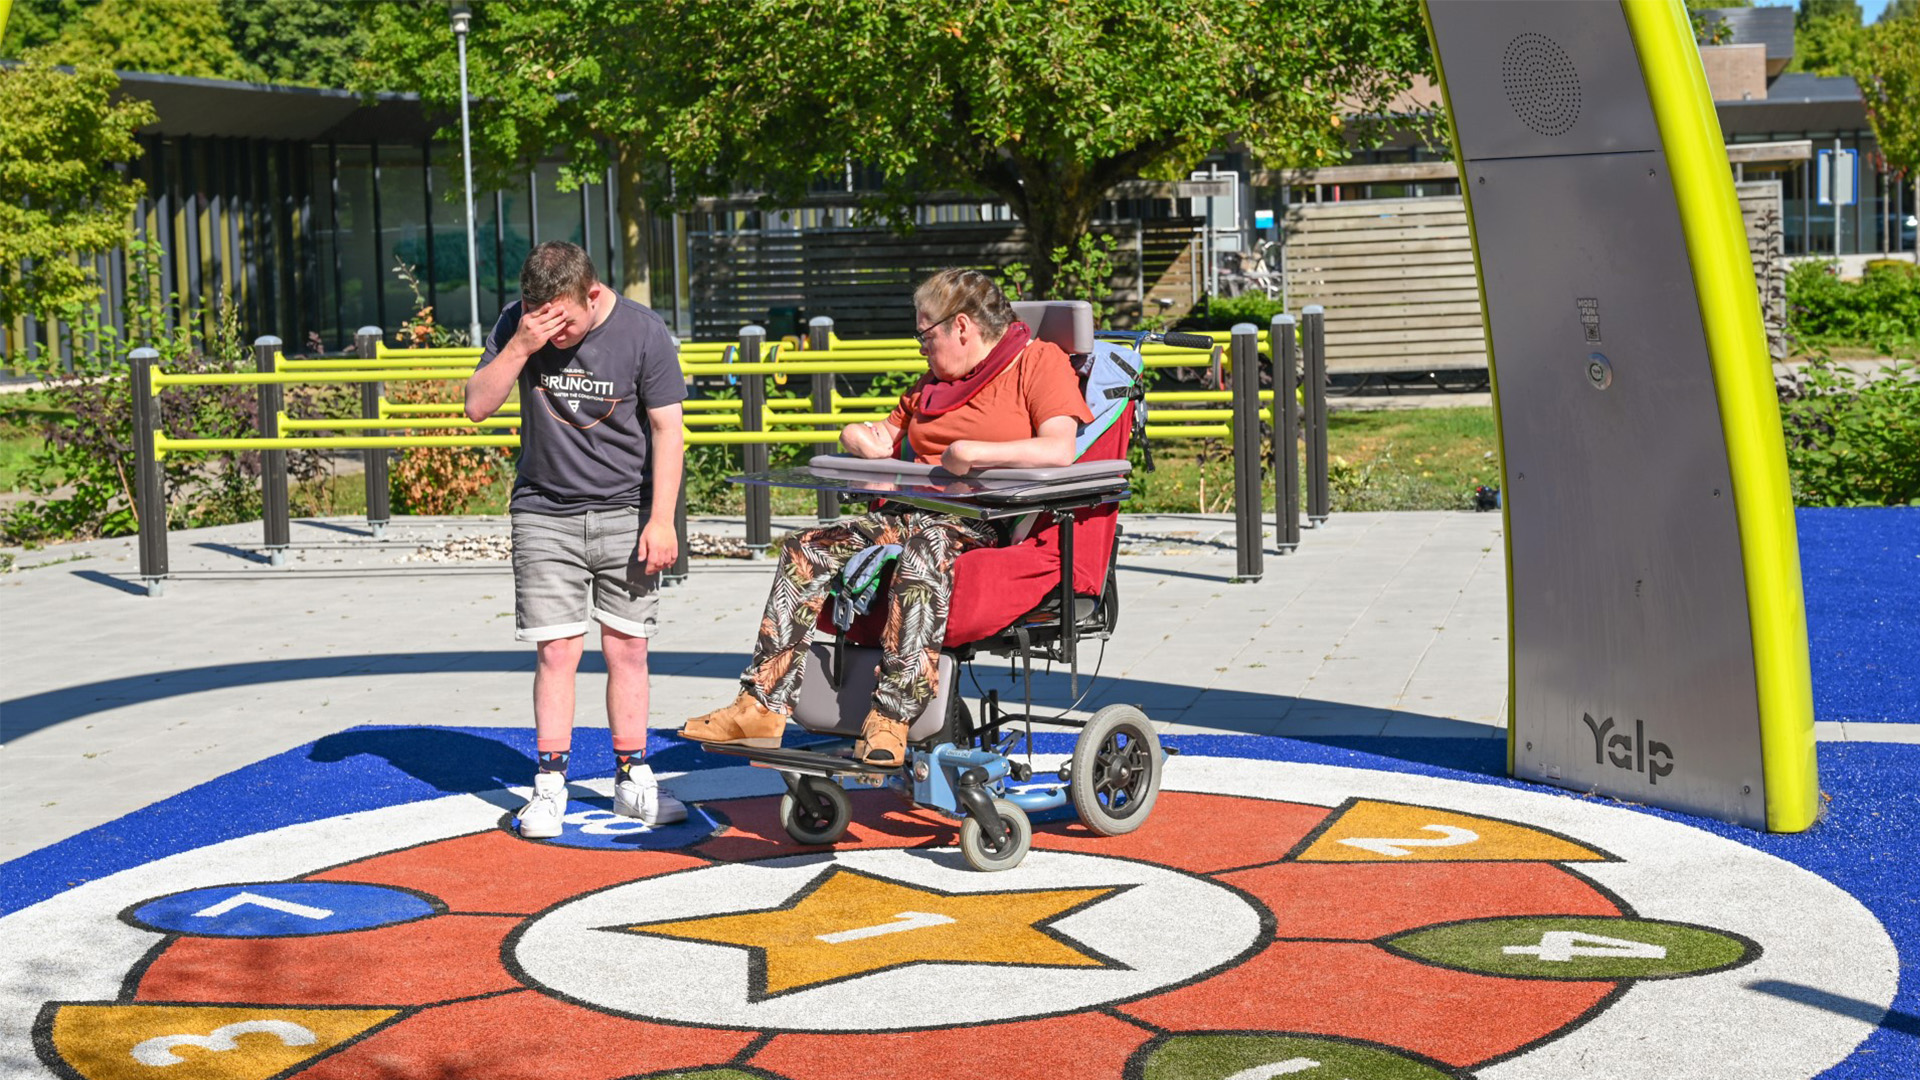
[28,0,261,81]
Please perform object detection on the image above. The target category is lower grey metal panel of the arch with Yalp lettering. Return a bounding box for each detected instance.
[1466,148,1764,828]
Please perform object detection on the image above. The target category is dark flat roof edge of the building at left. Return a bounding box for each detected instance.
[117,71,442,142]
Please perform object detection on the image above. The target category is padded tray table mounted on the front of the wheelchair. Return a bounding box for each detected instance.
[730,454,1133,519]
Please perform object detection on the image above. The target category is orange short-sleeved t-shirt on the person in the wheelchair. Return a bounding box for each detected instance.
[887,342,1092,465]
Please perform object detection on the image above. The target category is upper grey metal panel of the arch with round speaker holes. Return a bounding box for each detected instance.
[1428,0,1661,161]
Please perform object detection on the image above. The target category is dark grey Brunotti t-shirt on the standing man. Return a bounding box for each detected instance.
[480,296,687,513]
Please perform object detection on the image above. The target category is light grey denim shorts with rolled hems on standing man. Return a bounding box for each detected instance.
[513,507,660,642]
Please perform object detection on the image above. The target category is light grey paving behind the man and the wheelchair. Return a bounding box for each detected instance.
[0,513,1512,857]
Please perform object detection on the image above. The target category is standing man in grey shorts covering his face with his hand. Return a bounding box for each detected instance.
[467,242,687,840]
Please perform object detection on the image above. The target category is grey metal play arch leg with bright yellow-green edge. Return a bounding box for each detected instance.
[1425,0,1818,832]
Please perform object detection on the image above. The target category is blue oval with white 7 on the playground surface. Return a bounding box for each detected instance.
[127,882,436,938]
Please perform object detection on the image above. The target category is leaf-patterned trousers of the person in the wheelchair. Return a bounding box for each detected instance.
[741,509,998,721]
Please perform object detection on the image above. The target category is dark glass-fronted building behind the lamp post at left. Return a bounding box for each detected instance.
[4,73,674,365]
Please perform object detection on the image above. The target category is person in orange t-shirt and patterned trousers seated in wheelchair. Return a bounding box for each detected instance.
[680,269,1092,767]
